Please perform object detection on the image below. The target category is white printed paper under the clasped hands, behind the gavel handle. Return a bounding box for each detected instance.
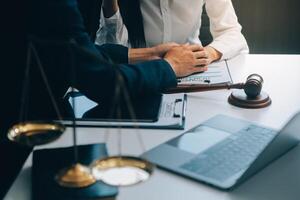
[178,60,232,84]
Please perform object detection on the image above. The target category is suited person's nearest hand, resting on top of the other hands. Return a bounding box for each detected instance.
[164,45,208,77]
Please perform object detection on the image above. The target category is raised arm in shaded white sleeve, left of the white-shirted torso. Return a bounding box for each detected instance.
[95,0,128,46]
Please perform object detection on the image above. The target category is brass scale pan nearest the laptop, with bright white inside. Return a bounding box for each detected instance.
[91,156,154,186]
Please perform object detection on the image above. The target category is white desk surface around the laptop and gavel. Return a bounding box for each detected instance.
[5,55,300,200]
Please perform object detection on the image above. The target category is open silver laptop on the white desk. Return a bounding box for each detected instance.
[142,112,300,189]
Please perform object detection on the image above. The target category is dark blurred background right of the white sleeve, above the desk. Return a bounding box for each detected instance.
[232,0,300,54]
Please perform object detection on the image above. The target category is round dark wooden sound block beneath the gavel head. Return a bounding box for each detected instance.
[228,90,272,109]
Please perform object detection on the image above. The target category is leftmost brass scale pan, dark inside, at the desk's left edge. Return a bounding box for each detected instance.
[8,122,65,146]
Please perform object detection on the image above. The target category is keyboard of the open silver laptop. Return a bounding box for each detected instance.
[180,125,275,181]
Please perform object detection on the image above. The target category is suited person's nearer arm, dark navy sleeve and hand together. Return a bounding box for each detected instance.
[76,45,207,103]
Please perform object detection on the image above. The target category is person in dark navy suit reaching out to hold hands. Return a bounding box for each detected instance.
[0,0,205,197]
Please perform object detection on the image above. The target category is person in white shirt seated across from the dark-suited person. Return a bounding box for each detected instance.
[95,0,249,64]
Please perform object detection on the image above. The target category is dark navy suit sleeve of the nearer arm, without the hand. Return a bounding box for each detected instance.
[75,42,177,104]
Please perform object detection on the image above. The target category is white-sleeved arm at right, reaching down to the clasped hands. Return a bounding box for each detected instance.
[206,0,249,59]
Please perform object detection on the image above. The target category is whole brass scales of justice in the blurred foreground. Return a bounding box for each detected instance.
[7,38,154,188]
